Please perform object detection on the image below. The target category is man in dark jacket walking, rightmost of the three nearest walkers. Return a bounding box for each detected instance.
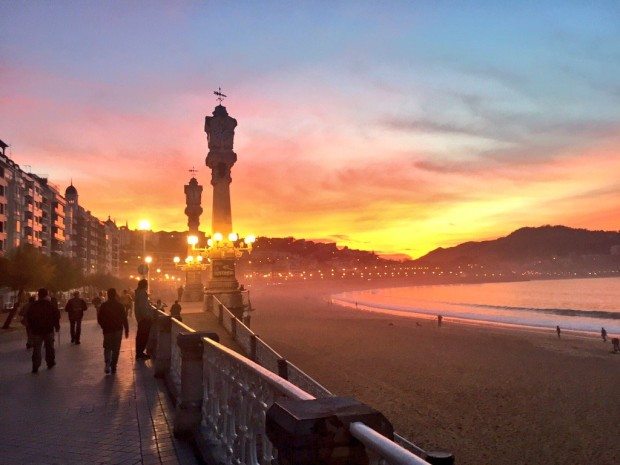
[97,289,129,375]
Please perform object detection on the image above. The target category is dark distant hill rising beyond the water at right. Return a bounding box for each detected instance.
[414,225,620,266]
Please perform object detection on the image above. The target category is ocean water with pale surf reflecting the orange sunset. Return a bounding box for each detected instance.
[332,277,620,336]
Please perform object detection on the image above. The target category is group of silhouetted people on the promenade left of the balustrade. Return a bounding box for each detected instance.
[20,279,181,374]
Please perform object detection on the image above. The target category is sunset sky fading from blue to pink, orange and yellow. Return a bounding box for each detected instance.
[0,1,620,257]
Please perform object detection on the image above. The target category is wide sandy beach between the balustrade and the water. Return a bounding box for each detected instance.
[245,281,620,465]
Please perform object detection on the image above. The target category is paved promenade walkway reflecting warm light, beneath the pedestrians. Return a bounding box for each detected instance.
[0,309,199,465]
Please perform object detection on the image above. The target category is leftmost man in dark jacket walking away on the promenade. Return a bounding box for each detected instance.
[26,289,60,373]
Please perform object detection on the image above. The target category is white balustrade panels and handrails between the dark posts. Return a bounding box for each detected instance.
[200,297,440,465]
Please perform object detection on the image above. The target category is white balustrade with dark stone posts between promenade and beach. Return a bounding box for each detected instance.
[149,299,454,465]
